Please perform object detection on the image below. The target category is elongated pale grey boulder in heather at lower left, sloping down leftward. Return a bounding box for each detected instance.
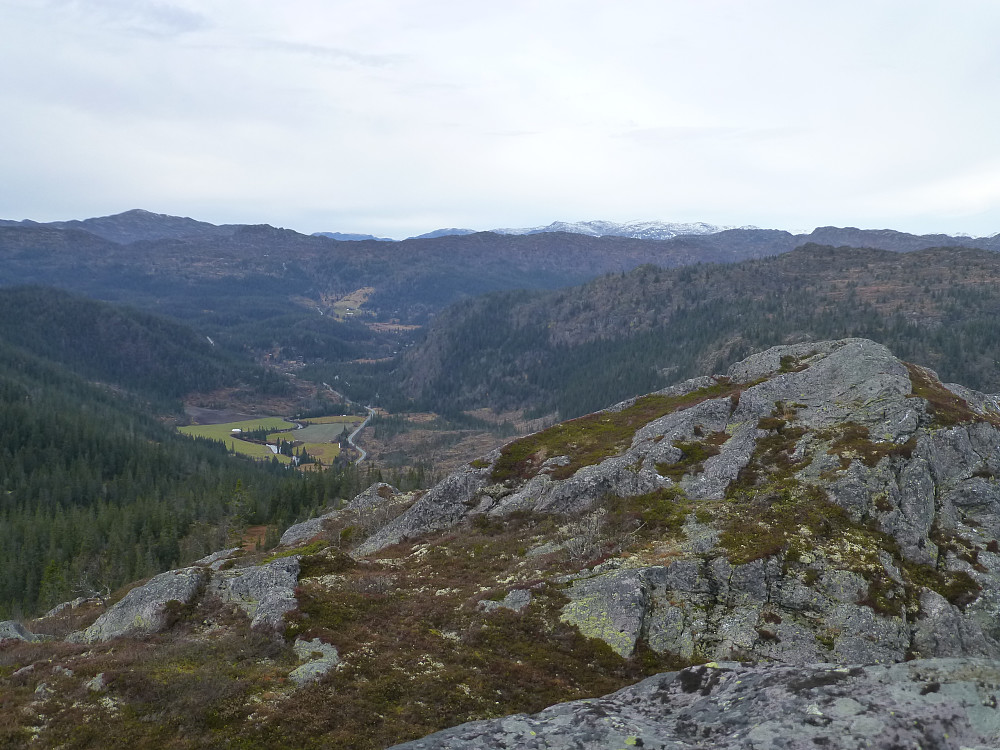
[66,568,208,643]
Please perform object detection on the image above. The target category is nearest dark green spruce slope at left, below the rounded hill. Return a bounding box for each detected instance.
[0,338,380,619]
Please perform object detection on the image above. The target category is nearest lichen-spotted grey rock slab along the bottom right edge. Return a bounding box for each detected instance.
[394,659,1000,750]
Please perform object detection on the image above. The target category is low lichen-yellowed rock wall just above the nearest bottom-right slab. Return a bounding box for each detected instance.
[561,556,988,664]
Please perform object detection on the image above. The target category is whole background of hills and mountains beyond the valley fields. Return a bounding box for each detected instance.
[0,211,1000,416]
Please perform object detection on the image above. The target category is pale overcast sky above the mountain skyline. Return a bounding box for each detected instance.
[0,0,1000,239]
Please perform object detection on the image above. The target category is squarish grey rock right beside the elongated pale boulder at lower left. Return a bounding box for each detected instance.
[208,555,299,631]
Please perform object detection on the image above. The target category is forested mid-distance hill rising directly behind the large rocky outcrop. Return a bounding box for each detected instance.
[402,245,1000,417]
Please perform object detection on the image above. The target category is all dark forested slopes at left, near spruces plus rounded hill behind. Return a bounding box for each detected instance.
[0,288,390,619]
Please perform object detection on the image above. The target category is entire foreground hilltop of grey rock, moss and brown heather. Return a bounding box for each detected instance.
[0,339,1000,748]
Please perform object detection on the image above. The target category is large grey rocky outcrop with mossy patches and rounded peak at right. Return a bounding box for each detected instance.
[355,339,1000,664]
